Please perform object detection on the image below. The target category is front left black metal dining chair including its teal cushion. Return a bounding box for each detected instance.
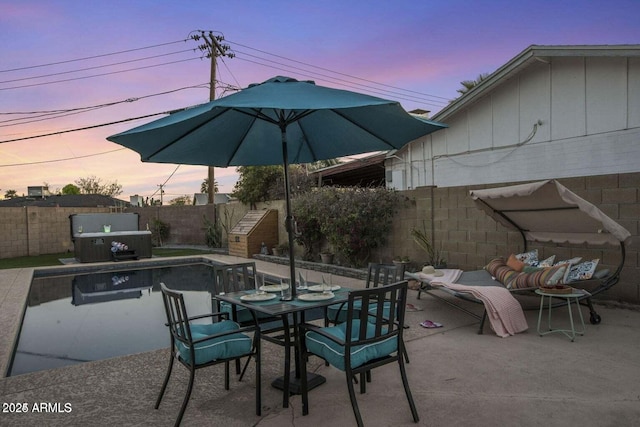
[155,283,262,426]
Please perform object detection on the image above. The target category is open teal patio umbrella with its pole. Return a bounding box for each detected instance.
[107,76,445,295]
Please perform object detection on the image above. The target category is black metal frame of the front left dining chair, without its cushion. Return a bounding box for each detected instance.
[155,283,262,426]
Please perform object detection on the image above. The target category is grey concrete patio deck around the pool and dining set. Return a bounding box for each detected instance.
[0,255,640,427]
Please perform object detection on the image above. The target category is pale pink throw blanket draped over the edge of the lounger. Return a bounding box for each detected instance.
[416,269,529,338]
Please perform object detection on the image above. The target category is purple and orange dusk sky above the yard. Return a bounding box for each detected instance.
[0,0,640,203]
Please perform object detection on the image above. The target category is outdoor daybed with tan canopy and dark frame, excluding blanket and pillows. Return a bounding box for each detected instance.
[406,180,631,333]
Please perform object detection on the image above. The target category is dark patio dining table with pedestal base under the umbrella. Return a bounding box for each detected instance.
[215,284,350,408]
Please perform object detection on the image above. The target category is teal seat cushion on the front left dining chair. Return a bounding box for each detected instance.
[177,320,252,365]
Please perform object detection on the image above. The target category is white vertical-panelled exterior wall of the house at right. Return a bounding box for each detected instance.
[386,53,640,190]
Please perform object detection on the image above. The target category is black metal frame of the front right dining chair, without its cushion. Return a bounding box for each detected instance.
[299,280,419,426]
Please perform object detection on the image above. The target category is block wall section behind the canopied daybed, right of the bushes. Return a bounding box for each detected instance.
[371,173,640,304]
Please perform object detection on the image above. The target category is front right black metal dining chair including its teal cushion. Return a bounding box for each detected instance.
[300,281,419,426]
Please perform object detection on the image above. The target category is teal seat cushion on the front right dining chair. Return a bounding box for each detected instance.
[305,320,398,371]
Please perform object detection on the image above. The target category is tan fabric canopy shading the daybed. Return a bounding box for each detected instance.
[470,180,631,246]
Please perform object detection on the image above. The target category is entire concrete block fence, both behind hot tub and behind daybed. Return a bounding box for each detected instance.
[0,173,640,304]
